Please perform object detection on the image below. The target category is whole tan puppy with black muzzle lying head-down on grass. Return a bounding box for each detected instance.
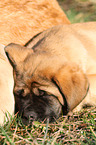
[5,22,96,124]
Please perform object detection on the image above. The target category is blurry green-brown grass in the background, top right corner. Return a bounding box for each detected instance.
[58,0,96,23]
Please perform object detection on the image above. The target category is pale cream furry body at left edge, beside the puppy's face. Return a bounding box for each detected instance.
[0,45,14,124]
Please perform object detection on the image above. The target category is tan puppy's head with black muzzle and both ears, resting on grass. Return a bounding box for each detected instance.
[5,44,88,124]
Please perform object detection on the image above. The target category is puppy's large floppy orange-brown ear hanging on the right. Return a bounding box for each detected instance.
[53,65,89,111]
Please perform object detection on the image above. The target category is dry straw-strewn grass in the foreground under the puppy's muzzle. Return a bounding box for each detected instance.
[0,107,96,145]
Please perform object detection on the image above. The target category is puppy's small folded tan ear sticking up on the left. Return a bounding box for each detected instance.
[5,43,33,67]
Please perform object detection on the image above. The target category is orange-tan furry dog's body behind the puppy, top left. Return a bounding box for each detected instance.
[0,0,70,45]
